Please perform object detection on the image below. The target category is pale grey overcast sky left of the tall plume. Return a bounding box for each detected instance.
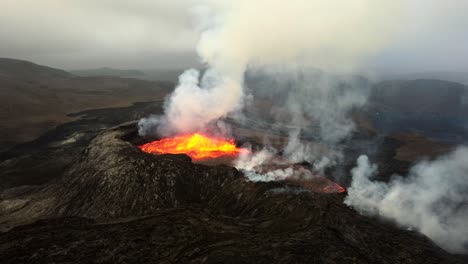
[0,0,197,68]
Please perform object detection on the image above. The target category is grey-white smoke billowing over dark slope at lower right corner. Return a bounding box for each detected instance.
[345,147,468,253]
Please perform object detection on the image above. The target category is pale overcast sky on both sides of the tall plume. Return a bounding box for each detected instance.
[0,0,468,73]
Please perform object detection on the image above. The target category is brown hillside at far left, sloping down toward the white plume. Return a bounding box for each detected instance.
[0,59,174,151]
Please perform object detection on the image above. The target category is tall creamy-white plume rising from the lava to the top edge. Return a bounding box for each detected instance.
[139,0,403,138]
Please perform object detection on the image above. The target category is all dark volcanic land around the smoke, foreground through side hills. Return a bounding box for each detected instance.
[0,60,468,263]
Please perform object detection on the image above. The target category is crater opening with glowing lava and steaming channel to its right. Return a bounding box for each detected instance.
[132,129,346,193]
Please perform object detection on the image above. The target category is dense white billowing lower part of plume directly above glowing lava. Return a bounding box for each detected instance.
[139,69,242,136]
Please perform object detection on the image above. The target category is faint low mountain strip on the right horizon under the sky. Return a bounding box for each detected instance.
[384,72,468,85]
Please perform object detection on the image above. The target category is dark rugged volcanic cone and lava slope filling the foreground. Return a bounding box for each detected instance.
[0,123,463,264]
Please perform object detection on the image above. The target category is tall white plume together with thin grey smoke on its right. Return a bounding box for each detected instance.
[139,0,401,186]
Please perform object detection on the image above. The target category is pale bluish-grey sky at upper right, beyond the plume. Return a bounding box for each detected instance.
[367,0,468,73]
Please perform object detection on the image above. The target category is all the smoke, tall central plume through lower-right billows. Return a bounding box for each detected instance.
[139,0,468,252]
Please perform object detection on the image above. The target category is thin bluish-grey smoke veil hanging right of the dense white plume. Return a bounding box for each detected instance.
[248,67,371,144]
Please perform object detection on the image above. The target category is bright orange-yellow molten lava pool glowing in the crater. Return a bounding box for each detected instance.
[139,133,248,160]
